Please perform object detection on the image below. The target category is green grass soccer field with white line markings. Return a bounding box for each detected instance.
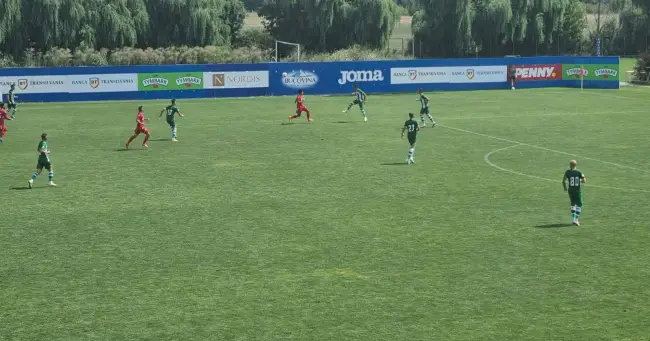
[0,88,650,341]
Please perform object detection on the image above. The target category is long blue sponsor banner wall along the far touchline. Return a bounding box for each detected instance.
[0,56,619,102]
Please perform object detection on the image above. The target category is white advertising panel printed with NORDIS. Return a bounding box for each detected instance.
[203,71,269,89]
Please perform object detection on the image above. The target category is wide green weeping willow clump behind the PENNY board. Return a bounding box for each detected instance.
[412,0,588,57]
